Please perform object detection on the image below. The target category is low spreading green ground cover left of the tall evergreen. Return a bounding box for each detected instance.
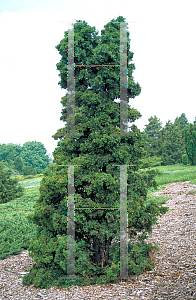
[0,186,39,259]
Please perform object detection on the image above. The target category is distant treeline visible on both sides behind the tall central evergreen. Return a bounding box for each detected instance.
[0,113,196,176]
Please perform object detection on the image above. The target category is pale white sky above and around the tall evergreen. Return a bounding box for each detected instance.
[0,0,196,159]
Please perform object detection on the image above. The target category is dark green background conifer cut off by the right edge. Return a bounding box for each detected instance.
[185,124,196,166]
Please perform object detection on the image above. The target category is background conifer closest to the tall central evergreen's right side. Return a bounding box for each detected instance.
[144,116,162,157]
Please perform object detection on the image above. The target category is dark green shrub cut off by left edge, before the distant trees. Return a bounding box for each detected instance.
[0,162,24,203]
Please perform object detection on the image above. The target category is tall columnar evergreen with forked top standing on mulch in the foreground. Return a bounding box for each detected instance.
[23,17,167,287]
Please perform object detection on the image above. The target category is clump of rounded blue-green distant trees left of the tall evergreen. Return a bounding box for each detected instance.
[0,141,51,176]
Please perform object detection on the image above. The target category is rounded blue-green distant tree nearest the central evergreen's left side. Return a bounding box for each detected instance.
[21,141,49,174]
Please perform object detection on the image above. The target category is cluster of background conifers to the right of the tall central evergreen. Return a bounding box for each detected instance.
[141,113,196,168]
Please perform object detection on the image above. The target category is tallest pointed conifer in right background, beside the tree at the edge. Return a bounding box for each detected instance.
[162,120,186,166]
